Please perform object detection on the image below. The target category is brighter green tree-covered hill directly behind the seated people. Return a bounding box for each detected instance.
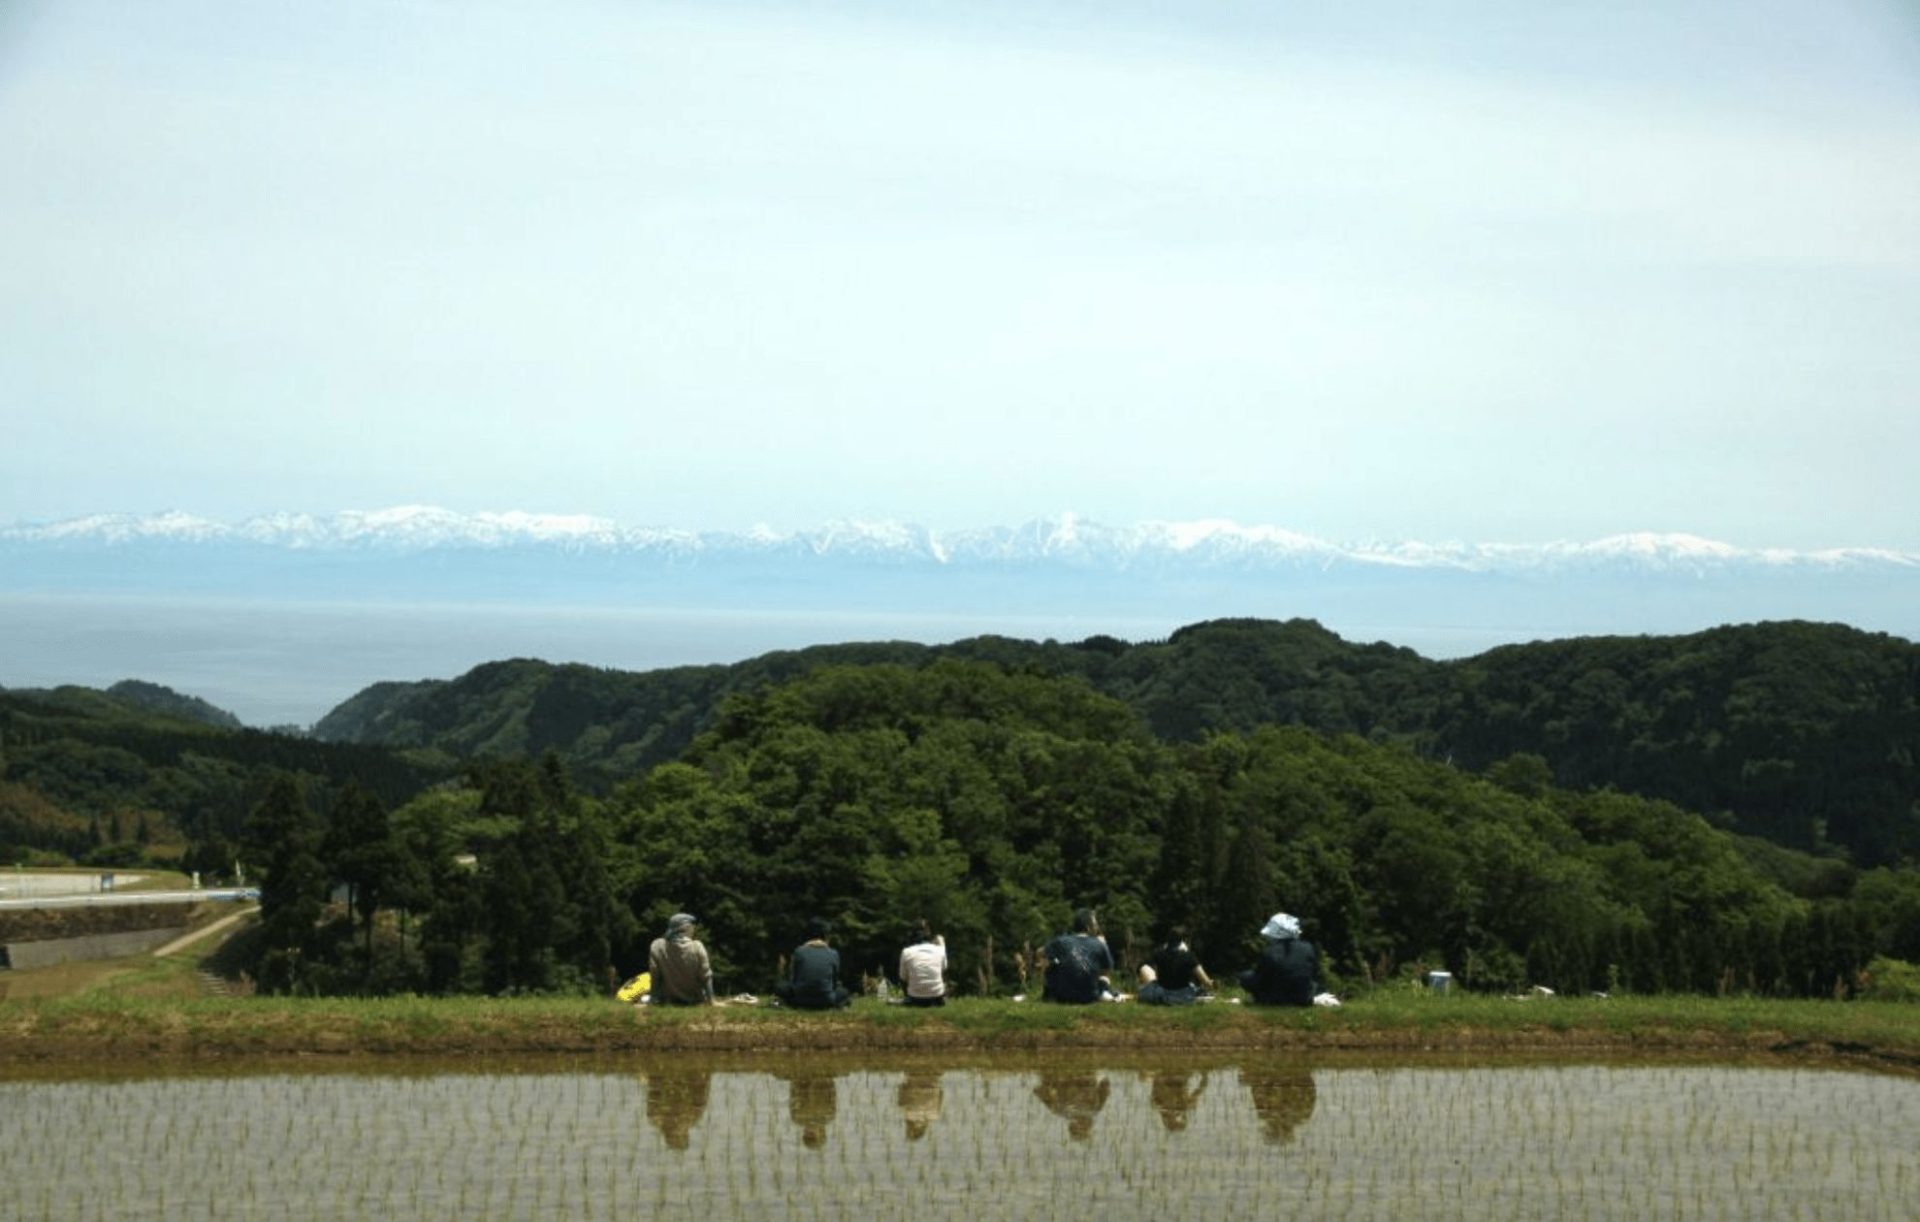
[240,659,1920,997]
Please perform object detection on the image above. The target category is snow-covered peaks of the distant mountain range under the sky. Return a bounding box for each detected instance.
[0,505,1920,580]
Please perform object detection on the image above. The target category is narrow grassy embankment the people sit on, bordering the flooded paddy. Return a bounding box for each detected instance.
[0,972,1920,1068]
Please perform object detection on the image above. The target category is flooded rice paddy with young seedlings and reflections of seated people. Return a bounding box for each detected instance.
[0,1057,1920,1220]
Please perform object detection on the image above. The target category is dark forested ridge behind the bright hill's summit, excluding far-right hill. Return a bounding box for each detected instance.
[313,619,1442,786]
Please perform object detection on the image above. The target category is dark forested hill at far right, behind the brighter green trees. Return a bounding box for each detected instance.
[1434,623,1920,865]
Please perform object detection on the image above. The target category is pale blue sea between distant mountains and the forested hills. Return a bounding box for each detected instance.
[0,594,1528,726]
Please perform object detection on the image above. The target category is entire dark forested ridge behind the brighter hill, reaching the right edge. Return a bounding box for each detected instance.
[315,619,1920,865]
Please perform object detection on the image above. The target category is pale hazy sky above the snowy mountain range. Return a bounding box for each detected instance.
[0,0,1920,548]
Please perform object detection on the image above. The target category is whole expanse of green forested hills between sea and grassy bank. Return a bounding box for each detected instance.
[0,621,1920,995]
